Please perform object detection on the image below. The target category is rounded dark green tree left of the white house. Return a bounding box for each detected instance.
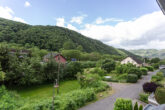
[101,59,116,73]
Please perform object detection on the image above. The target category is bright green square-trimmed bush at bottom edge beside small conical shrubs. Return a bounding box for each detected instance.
[114,98,132,110]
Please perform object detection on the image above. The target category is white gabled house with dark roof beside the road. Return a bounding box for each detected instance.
[121,57,143,67]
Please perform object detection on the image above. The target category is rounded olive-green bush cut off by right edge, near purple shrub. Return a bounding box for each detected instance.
[155,87,165,104]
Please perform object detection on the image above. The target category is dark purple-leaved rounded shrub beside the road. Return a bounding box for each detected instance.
[143,82,158,92]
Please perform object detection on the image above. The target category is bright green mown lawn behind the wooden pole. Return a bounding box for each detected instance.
[11,80,80,100]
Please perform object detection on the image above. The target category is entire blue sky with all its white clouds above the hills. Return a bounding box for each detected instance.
[0,0,165,49]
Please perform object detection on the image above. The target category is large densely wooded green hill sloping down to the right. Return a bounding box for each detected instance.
[0,18,136,56]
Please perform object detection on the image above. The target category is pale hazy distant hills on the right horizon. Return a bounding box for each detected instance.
[129,49,165,59]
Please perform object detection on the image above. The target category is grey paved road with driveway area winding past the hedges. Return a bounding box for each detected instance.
[79,71,157,110]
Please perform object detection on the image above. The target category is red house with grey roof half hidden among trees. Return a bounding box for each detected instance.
[43,53,66,64]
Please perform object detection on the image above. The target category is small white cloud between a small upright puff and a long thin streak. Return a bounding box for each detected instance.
[70,15,87,24]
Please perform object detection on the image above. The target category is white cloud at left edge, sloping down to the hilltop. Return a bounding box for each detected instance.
[0,6,26,23]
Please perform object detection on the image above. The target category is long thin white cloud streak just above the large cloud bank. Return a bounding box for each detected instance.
[95,17,124,24]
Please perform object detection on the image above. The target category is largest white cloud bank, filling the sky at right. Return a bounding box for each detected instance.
[78,11,165,49]
